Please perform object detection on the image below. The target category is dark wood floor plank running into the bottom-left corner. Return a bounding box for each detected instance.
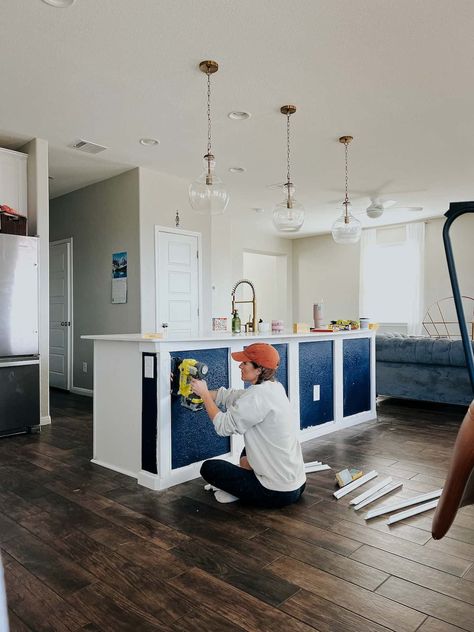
[3,554,92,632]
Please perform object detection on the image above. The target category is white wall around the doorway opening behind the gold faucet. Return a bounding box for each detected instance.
[212,215,293,327]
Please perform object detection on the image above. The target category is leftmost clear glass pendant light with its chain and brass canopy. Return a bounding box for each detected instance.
[189,60,229,215]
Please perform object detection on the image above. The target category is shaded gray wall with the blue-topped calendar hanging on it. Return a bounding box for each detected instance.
[50,169,140,389]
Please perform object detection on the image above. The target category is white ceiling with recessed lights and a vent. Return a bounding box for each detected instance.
[0,0,474,236]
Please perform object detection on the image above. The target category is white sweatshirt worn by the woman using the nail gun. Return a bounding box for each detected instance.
[214,380,306,492]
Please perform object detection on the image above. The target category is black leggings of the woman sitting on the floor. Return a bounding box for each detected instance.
[201,459,306,508]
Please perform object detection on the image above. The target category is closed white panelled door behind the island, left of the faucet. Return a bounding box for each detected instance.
[156,229,200,336]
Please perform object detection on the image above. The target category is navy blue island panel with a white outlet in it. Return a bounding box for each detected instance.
[298,340,334,429]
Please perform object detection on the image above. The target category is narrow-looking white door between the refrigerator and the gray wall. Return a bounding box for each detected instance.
[49,241,71,390]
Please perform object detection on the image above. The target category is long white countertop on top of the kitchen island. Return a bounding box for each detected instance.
[81,329,375,344]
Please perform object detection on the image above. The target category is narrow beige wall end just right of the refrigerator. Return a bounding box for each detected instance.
[20,138,51,424]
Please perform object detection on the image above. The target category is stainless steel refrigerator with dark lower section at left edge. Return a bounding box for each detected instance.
[0,233,40,436]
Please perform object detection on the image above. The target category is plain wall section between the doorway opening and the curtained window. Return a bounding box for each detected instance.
[293,235,360,324]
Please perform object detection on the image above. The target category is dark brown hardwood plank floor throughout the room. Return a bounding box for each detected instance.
[0,392,474,632]
